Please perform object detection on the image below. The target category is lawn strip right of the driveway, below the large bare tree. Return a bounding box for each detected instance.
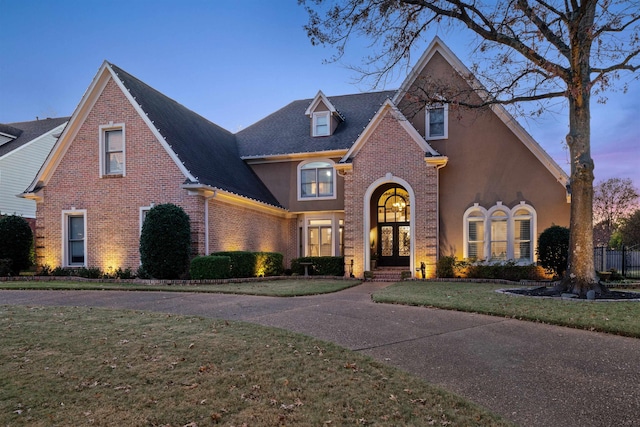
[373,281,640,338]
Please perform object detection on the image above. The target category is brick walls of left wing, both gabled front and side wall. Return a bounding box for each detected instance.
[36,80,295,272]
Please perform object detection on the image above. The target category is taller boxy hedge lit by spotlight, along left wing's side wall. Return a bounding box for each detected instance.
[211,251,284,278]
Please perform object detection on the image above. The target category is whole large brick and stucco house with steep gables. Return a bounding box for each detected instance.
[23,39,570,277]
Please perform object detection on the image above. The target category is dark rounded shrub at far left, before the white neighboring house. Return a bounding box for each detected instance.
[0,215,33,275]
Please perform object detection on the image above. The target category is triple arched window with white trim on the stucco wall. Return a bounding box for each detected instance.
[464,202,536,263]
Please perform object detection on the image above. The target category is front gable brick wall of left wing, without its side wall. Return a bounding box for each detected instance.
[36,77,204,270]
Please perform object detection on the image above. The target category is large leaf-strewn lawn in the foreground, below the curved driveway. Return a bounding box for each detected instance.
[0,306,509,427]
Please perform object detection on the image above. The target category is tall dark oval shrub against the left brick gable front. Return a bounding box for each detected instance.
[140,203,191,279]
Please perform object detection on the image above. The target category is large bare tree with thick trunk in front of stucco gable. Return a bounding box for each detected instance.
[298,0,640,294]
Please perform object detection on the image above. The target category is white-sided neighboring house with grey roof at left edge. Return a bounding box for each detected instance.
[0,117,69,227]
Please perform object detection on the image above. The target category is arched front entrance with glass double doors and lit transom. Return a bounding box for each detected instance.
[376,186,411,266]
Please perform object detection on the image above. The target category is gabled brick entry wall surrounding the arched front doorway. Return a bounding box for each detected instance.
[345,111,438,276]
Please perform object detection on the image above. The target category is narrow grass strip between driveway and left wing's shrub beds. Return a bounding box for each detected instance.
[0,279,361,297]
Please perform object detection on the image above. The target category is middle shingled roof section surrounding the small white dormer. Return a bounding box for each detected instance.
[236,91,395,159]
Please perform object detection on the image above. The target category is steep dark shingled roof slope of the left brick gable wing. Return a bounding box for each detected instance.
[109,64,281,207]
